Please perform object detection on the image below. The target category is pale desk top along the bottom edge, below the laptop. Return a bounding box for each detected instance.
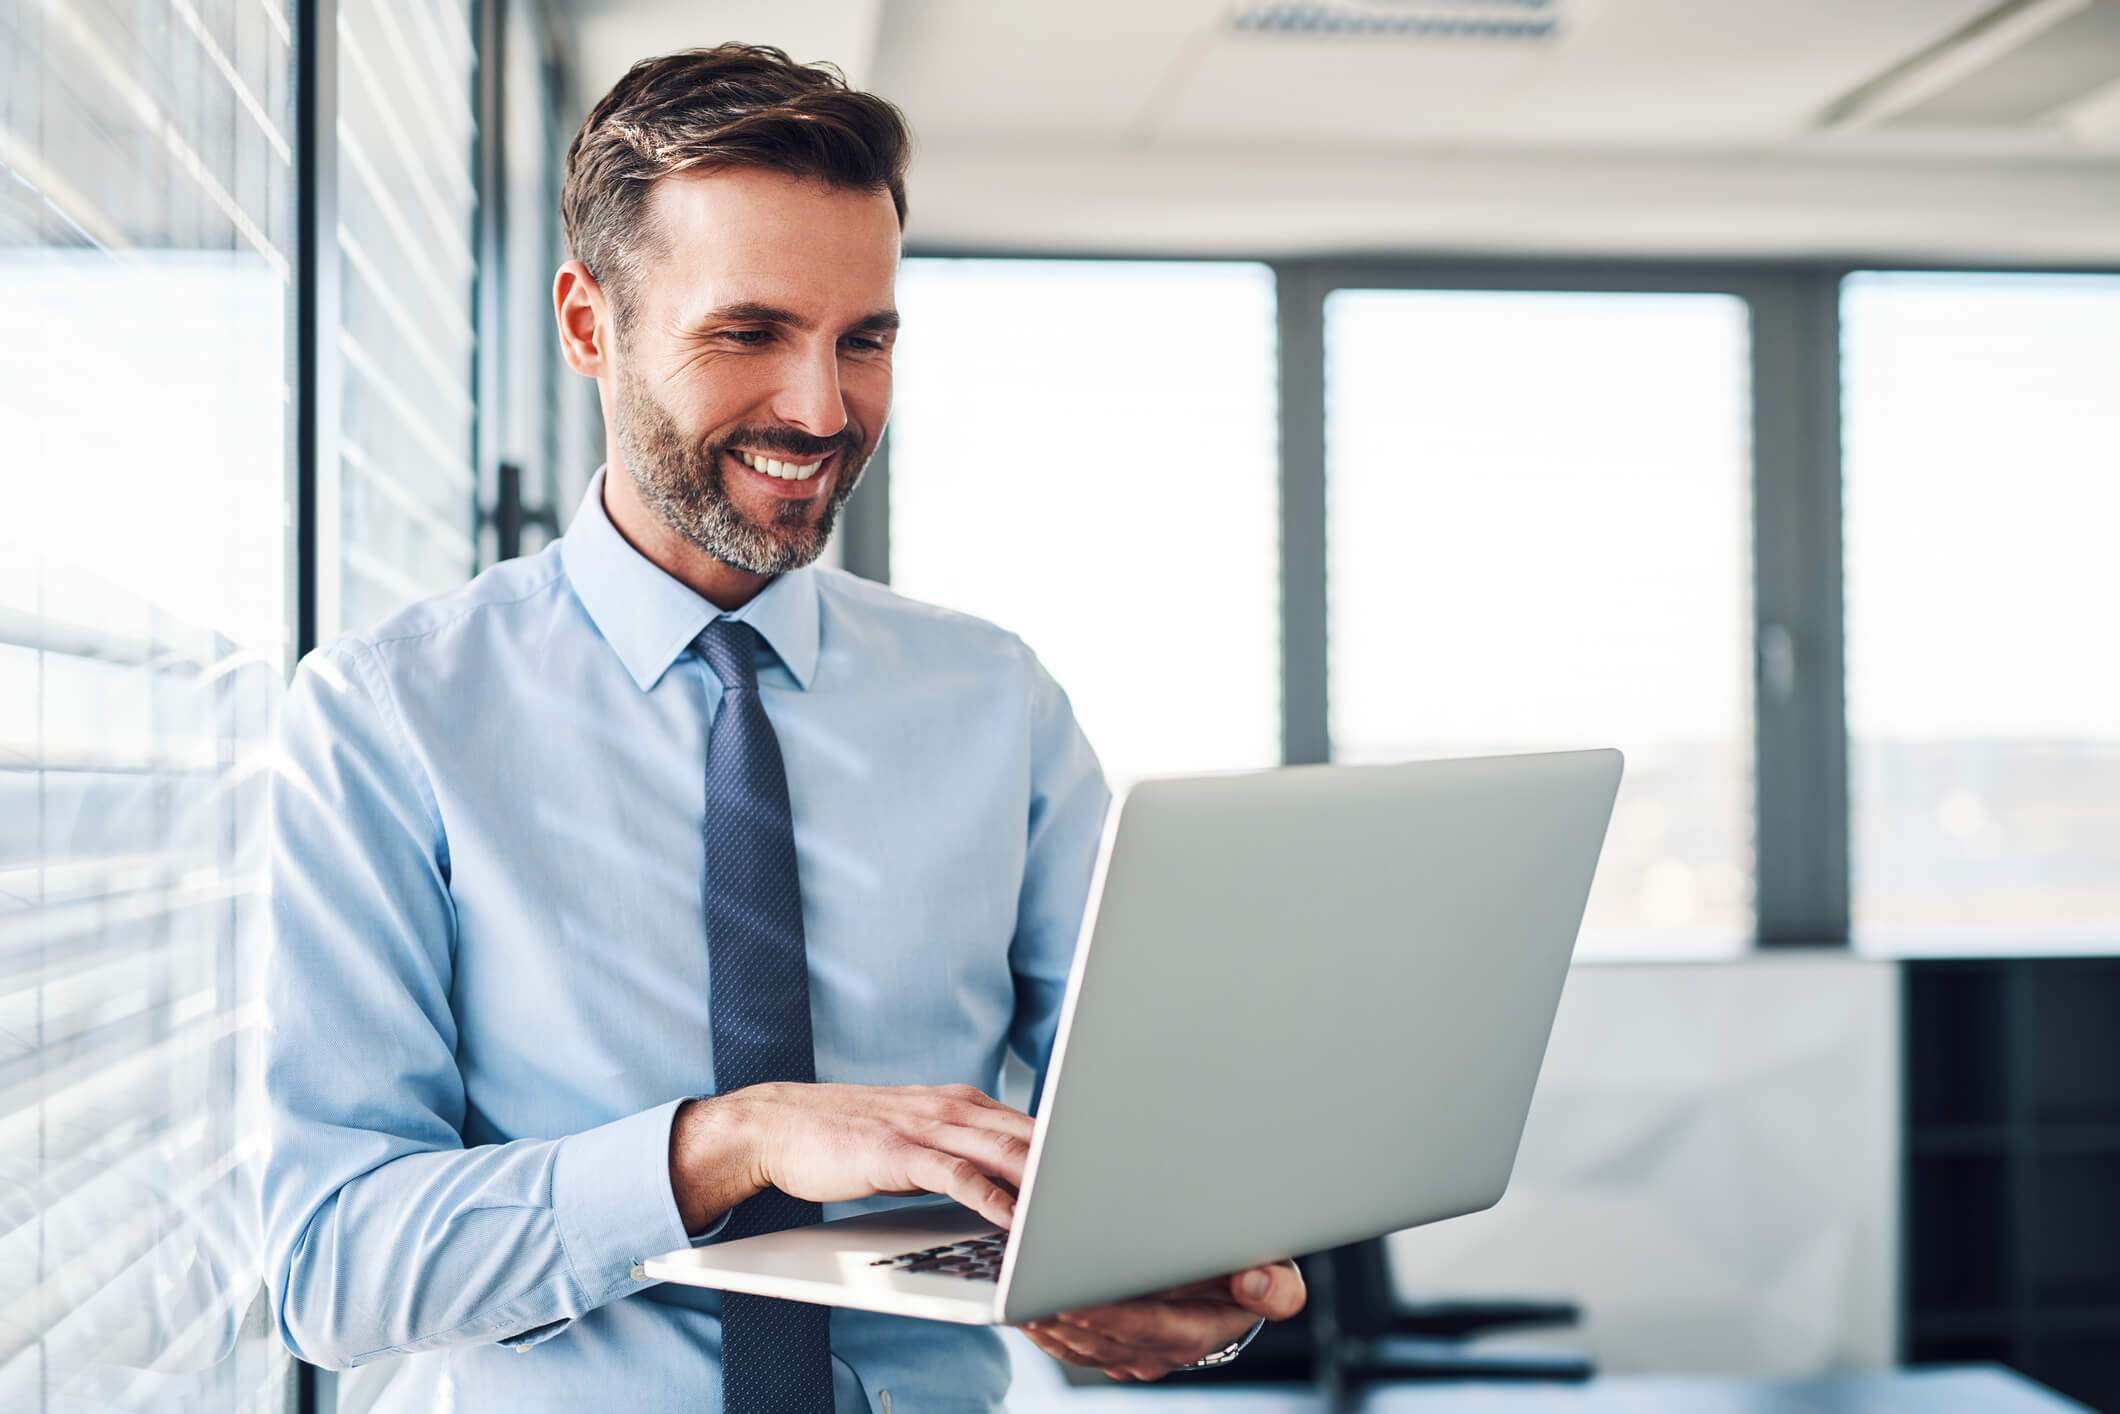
[1009,1357,2090,1414]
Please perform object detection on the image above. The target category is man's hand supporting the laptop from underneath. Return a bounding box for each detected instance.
[1022,1261,1304,1380]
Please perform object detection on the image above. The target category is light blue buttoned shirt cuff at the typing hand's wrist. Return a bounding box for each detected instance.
[551,1098,693,1306]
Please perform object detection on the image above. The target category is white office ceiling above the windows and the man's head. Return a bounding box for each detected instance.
[572,0,2120,265]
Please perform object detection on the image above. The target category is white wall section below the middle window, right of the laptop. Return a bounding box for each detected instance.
[1391,956,1900,1374]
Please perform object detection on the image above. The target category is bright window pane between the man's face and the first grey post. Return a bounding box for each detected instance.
[890,261,1280,782]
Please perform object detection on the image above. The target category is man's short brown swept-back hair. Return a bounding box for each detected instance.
[560,45,912,326]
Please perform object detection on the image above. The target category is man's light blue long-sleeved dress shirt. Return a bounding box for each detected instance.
[263,475,1109,1414]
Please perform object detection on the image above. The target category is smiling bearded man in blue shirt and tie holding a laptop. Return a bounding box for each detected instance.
[265,47,1304,1414]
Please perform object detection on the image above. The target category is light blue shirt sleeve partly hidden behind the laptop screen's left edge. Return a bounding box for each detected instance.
[1009,649,1111,1113]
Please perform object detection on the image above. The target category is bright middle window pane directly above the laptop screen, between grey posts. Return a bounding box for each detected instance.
[1325,290,1753,956]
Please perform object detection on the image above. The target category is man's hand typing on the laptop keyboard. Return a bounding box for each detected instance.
[670,1083,1021,1229]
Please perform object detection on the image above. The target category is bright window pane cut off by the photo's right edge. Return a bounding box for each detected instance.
[1840,273,2120,952]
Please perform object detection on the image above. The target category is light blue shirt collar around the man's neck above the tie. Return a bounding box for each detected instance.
[560,466,818,691]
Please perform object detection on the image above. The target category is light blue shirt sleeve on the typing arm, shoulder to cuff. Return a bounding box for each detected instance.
[261,640,689,1369]
